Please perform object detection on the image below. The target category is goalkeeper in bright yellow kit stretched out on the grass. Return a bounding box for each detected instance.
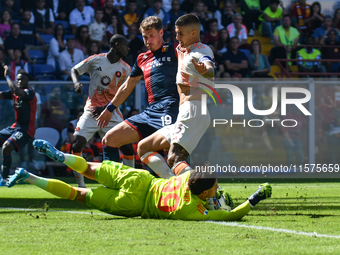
[7,140,271,221]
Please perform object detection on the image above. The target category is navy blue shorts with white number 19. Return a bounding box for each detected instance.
[125,98,179,140]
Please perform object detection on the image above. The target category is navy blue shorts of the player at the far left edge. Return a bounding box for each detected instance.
[0,127,32,152]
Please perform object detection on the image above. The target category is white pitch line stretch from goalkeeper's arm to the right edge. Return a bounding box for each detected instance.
[206,221,340,239]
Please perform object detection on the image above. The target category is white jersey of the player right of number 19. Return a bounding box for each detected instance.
[176,42,215,88]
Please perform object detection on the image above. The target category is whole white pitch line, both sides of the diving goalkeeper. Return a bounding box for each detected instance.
[0,207,340,239]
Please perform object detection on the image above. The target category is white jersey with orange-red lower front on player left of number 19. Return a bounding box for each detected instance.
[75,53,131,109]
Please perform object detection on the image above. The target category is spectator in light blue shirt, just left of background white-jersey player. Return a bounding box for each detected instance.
[59,37,85,81]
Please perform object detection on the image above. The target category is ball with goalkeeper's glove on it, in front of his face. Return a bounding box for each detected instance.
[205,187,233,212]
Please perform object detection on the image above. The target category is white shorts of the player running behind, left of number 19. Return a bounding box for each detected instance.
[73,109,123,141]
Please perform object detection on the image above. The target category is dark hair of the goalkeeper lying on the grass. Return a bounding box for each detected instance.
[188,169,217,195]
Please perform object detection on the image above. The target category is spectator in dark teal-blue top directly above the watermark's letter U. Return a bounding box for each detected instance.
[248,39,271,78]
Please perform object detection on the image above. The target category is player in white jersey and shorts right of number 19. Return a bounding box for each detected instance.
[138,14,215,177]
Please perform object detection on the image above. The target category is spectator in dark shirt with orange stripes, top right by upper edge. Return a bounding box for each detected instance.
[290,0,311,43]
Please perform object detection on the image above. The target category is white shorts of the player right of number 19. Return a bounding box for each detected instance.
[157,100,210,154]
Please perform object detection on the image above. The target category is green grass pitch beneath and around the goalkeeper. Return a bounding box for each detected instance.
[0,178,340,254]
